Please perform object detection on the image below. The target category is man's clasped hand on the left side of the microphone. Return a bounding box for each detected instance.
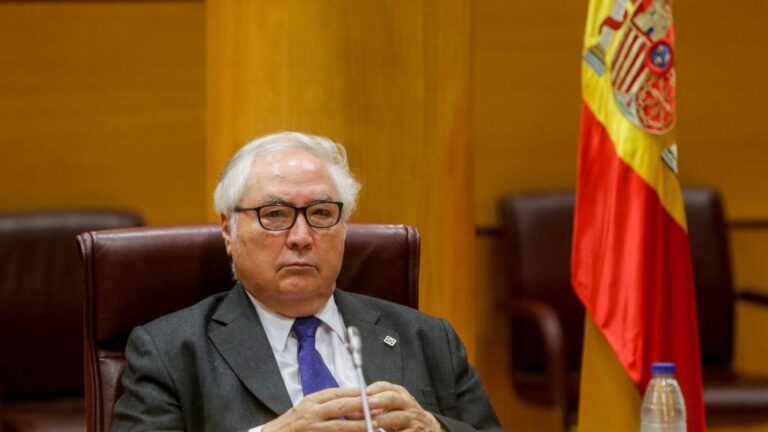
[262,388,374,432]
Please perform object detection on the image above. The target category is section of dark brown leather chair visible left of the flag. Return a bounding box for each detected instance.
[500,192,584,427]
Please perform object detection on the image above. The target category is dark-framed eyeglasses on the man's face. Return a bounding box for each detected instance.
[235,201,344,231]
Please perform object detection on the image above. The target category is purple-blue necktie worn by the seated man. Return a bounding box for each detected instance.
[293,316,339,396]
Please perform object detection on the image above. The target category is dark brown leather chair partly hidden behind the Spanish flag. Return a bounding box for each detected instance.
[501,188,768,427]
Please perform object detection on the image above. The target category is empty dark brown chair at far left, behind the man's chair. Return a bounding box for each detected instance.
[0,211,142,432]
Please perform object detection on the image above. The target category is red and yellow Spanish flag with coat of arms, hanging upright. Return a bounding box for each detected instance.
[572,0,705,432]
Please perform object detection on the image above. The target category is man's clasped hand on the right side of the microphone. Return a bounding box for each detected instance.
[368,381,442,432]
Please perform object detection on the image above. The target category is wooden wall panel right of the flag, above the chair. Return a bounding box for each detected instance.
[674,0,768,219]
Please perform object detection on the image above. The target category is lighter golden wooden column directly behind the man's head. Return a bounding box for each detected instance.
[207,0,475,353]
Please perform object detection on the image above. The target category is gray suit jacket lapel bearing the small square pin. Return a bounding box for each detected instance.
[334,288,403,384]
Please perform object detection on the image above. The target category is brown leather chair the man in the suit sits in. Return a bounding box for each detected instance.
[78,224,420,431]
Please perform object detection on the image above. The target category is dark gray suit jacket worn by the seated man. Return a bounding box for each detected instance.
[113,284,500,432]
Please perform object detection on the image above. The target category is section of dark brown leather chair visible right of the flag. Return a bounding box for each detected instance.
[683,188,768,425]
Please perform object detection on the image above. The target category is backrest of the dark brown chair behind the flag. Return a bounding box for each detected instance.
[502,188,734,384]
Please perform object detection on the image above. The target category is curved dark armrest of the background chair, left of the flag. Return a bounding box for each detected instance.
[499,298,568,410]
